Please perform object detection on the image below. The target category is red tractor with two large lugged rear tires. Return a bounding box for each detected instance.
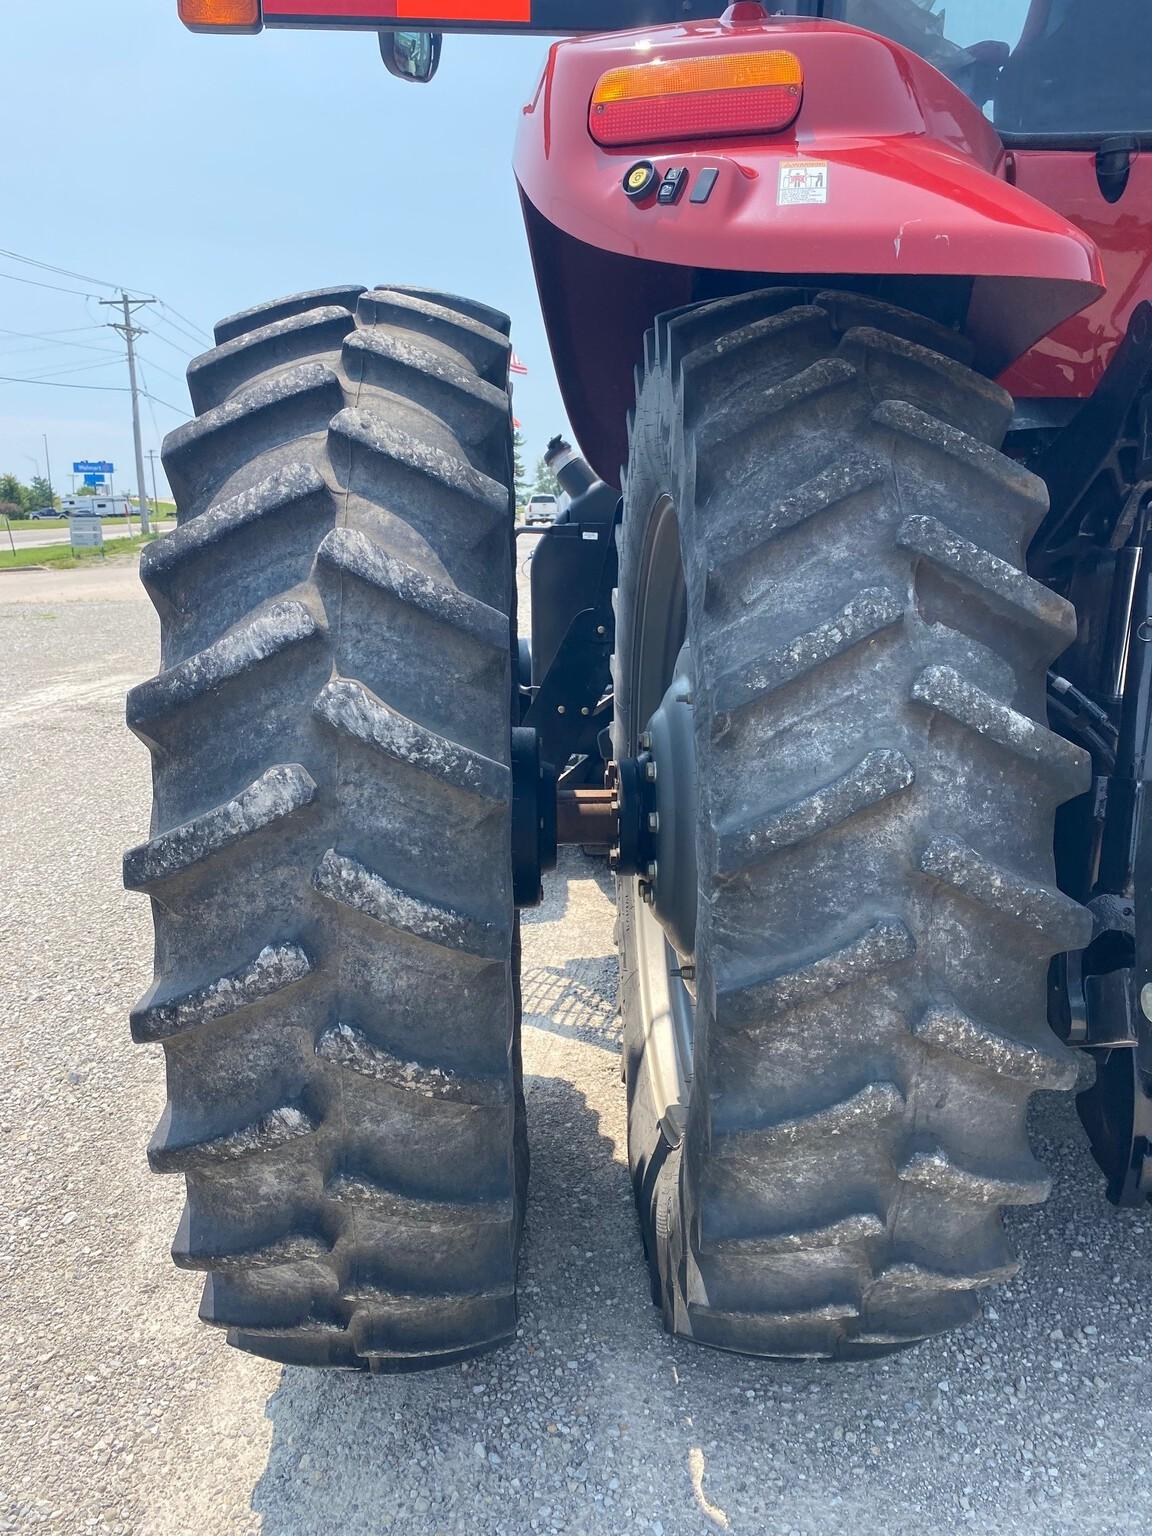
[126,0,1152,1370]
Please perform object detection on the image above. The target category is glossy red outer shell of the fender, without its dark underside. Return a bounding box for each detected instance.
[516,17,1103,373]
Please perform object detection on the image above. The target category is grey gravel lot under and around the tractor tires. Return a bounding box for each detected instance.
[0,564,1152,1536]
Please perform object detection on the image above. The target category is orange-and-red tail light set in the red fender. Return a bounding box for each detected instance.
[588,48,803,144]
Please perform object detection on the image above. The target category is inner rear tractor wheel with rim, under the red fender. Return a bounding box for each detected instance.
[616,290,1091,1358]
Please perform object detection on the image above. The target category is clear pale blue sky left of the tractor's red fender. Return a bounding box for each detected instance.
[0,0,564,488]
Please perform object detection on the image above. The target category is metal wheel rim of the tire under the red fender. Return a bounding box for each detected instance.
[627,496,697,1114]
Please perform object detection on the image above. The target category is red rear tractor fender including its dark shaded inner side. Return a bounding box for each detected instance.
[516,6,1103,481]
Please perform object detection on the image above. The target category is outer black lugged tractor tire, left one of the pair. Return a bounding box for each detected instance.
[124,287,527,1372]
